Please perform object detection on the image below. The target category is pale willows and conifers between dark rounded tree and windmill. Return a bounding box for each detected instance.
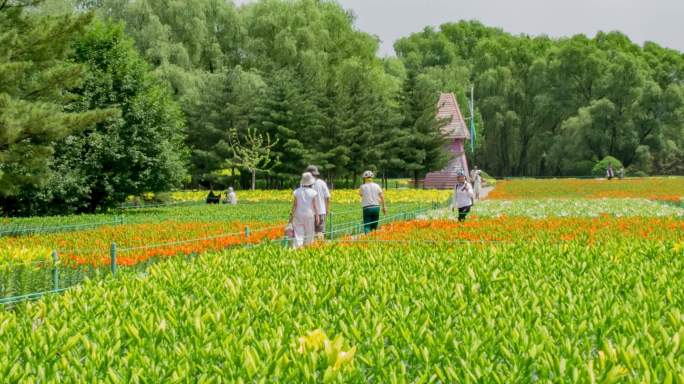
[86,0,422,187]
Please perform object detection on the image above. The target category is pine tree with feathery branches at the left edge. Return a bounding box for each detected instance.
[0,0,112,214]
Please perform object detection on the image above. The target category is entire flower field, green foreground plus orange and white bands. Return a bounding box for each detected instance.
[0,179,684,383]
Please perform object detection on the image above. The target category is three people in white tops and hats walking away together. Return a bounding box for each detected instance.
[286,165,387,248]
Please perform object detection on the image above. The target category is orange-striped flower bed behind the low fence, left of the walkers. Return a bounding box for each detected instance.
[0,202,432,303]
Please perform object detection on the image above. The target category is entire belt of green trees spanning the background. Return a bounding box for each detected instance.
[5,0,684,214]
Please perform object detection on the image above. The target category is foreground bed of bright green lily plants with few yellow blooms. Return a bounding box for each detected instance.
[0,235,684,383]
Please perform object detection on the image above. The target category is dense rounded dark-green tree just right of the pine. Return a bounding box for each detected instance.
[55,22,185,211]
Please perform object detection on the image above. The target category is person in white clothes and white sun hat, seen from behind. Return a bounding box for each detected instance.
[290,172,319,248]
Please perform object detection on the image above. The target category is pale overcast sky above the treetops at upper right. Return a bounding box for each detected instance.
[237,0,684,55]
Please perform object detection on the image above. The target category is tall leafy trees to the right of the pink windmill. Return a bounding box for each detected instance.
[395,22,684,176]
